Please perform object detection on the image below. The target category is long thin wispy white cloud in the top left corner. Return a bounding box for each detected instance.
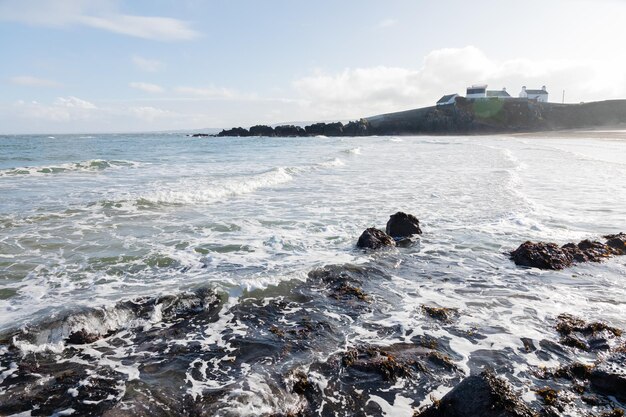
[0,0,200,41]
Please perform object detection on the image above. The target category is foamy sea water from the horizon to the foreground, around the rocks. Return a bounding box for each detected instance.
[0,132,626,416]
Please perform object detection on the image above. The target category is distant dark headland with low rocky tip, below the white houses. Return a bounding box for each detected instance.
[206,97,626,137]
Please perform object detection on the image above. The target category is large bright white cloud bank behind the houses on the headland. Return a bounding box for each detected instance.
[293,46,626,119]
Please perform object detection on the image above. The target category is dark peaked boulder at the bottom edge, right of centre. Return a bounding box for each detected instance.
[416,371,535,417]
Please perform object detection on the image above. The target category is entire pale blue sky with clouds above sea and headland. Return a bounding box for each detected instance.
[0,0,626,134]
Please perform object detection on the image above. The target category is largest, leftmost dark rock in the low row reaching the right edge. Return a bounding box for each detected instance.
[511,241,573,270]
